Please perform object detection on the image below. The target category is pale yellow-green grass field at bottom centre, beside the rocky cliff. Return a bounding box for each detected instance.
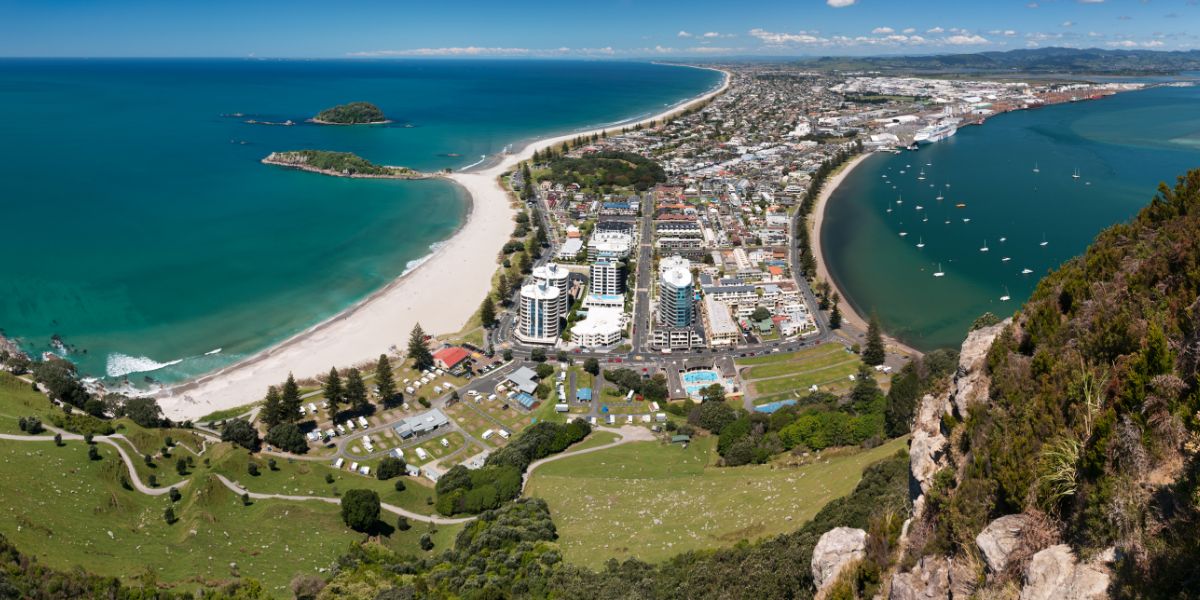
[527,437,905,568]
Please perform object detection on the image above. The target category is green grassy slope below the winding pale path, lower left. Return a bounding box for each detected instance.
[0,442,458,598]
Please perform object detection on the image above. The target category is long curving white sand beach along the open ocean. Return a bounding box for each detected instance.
[157,66,731,420]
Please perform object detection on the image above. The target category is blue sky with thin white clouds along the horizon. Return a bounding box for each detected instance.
[0,0,1200,58]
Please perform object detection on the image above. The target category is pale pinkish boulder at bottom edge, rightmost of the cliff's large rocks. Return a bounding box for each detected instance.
[1021,544,1109,600]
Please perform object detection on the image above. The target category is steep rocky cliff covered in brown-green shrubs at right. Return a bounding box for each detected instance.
[811,170,1200,600]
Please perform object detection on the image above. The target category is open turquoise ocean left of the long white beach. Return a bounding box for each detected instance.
[0,60,720,383]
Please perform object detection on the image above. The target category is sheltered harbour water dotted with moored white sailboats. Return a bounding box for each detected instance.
[822,82,1200,349]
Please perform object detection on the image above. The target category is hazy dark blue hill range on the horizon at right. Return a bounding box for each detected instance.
[809,48,1200,74]
